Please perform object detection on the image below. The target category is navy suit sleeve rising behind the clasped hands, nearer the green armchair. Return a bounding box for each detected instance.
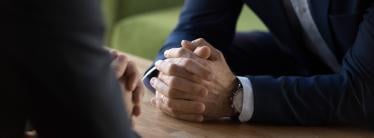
[144,0,243,90]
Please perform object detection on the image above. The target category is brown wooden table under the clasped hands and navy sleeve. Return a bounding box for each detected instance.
[129,55,374,138]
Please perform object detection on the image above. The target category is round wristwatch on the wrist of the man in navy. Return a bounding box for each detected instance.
[231,78,243,116]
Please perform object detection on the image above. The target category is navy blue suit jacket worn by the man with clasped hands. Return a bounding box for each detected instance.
[146,0,374,125]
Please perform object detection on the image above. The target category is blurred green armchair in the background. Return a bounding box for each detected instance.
[103,0,266,59]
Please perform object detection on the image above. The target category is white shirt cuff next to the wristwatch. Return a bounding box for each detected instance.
[238,76,254,122]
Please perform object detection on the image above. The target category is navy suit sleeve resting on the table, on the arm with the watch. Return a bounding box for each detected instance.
[248,4,374,125]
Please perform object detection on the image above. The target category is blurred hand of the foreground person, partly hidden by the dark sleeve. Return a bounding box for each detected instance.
[110,50,144,116]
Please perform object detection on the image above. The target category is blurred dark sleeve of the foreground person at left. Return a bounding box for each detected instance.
[0,0,135,138]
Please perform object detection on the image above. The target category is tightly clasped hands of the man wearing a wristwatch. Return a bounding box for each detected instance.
[151,39,236,122]
